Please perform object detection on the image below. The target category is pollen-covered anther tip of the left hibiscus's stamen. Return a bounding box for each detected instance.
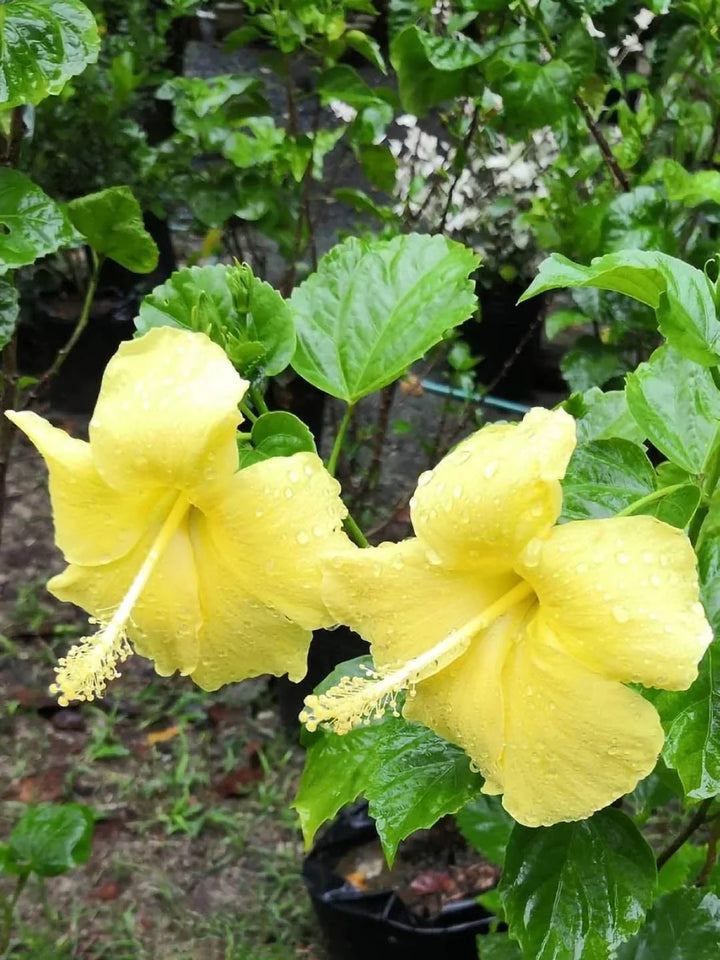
[50,620,133,707]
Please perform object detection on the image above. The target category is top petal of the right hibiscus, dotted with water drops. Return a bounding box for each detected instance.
[411,408,575,572]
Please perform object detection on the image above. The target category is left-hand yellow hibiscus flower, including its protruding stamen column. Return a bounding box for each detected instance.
[8,327,346,705]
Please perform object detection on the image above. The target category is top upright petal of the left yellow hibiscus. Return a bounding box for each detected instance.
[90,327,247,491]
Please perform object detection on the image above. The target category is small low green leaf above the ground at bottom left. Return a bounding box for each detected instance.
[6,803,95,877]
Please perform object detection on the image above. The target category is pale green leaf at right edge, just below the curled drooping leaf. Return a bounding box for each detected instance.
[625,345,720,474]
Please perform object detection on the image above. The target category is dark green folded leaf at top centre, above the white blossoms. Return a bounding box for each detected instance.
[390,24,486,117]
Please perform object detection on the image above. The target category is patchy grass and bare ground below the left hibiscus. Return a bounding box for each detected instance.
[0,604,323,960]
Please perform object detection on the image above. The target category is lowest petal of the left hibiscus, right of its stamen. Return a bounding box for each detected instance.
[192,513,312,690]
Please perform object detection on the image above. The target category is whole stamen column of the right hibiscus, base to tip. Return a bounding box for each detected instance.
[300,580,534,734]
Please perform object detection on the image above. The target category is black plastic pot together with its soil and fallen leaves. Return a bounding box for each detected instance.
[303,805,499,960]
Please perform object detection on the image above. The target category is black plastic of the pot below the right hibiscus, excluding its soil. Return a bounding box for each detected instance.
[303,804,495,960]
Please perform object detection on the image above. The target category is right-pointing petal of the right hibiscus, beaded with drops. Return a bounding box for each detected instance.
[518,517,712,690]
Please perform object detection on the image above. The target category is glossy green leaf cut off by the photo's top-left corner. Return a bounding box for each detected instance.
[0,0,100,109]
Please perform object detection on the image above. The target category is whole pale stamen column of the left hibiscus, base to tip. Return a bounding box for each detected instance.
[50,494,190,707]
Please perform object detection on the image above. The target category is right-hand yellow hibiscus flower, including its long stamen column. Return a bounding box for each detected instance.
[303,409,712,826]
